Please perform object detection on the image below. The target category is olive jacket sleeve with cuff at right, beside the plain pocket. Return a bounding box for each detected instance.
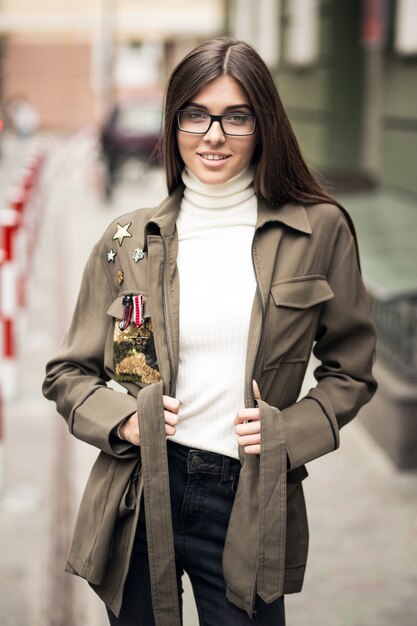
[282,217,377,469]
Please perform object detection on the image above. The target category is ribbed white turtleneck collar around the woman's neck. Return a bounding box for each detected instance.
[182,167,255,209]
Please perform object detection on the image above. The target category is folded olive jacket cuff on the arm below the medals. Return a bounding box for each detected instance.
[72,387,137,458]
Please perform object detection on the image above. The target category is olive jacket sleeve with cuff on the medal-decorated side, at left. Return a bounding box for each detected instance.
[42,244,137,458]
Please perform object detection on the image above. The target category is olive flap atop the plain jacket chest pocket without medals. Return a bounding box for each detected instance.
[271,276,334,309]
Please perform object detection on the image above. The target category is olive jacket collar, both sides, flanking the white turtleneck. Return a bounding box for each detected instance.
[144,184,313,246]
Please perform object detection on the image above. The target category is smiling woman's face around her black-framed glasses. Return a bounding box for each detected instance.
[177,75,256,185]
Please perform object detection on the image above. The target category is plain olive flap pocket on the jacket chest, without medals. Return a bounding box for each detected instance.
[264,275,334,370]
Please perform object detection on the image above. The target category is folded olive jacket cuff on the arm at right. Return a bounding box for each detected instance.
[282,387,340,470]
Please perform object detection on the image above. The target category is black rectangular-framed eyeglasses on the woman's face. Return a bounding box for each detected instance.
[177,109,256,137]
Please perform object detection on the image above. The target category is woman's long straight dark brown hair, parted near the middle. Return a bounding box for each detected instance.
[163,37,337,206]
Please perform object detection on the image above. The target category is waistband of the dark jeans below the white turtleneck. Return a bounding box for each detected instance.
[167,439,241,480]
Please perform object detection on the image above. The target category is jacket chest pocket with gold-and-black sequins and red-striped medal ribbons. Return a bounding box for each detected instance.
[107,292,161,385]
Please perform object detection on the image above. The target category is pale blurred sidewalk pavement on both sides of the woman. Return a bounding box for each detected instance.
[0,129,417,626]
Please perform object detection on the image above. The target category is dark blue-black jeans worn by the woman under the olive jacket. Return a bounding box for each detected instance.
[105,441,285,626]
